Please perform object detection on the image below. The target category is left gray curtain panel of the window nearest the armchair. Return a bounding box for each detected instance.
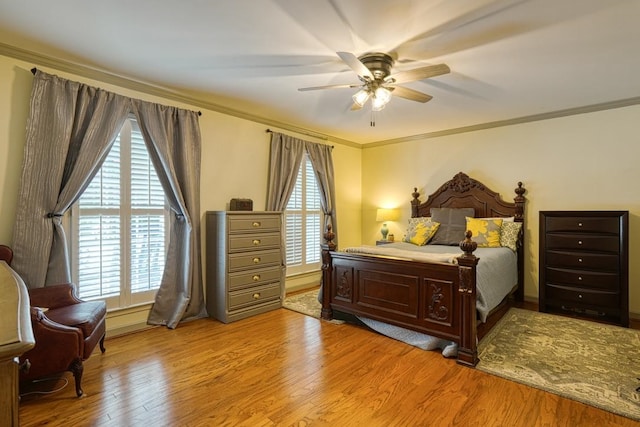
[11,70,130,288]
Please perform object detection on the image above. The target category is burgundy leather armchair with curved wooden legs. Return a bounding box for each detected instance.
[0,245,107,397]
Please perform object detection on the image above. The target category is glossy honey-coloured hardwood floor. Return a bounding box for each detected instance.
[20,309,638,427]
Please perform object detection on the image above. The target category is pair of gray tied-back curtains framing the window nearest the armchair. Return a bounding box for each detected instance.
[12,71,206,328]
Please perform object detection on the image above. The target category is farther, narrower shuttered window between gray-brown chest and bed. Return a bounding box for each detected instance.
[284,153,322,275]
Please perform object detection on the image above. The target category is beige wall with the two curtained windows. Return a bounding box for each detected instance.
[0,55,362,329]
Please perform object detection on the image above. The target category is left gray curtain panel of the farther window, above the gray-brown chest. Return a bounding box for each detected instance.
[267,132,305,212]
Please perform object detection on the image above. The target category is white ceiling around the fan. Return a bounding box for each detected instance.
[0,0,640,143]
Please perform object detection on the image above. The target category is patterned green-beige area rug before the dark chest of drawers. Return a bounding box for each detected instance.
[477,308,640,421]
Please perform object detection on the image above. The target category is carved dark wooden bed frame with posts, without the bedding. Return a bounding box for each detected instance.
[322,172,525,366]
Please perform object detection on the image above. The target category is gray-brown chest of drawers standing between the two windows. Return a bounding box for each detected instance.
[206,211,285,323]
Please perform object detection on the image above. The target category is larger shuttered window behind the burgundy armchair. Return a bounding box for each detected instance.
[72,118,168,308]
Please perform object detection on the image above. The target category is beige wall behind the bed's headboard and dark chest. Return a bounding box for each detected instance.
[362,106,640,317]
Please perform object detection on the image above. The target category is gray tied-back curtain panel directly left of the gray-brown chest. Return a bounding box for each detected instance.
[133,100,206,328]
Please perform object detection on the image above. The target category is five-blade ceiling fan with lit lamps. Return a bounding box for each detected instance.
[298,52,451,113]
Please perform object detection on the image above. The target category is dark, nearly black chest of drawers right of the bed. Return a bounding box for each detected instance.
[539,211,629,326]
